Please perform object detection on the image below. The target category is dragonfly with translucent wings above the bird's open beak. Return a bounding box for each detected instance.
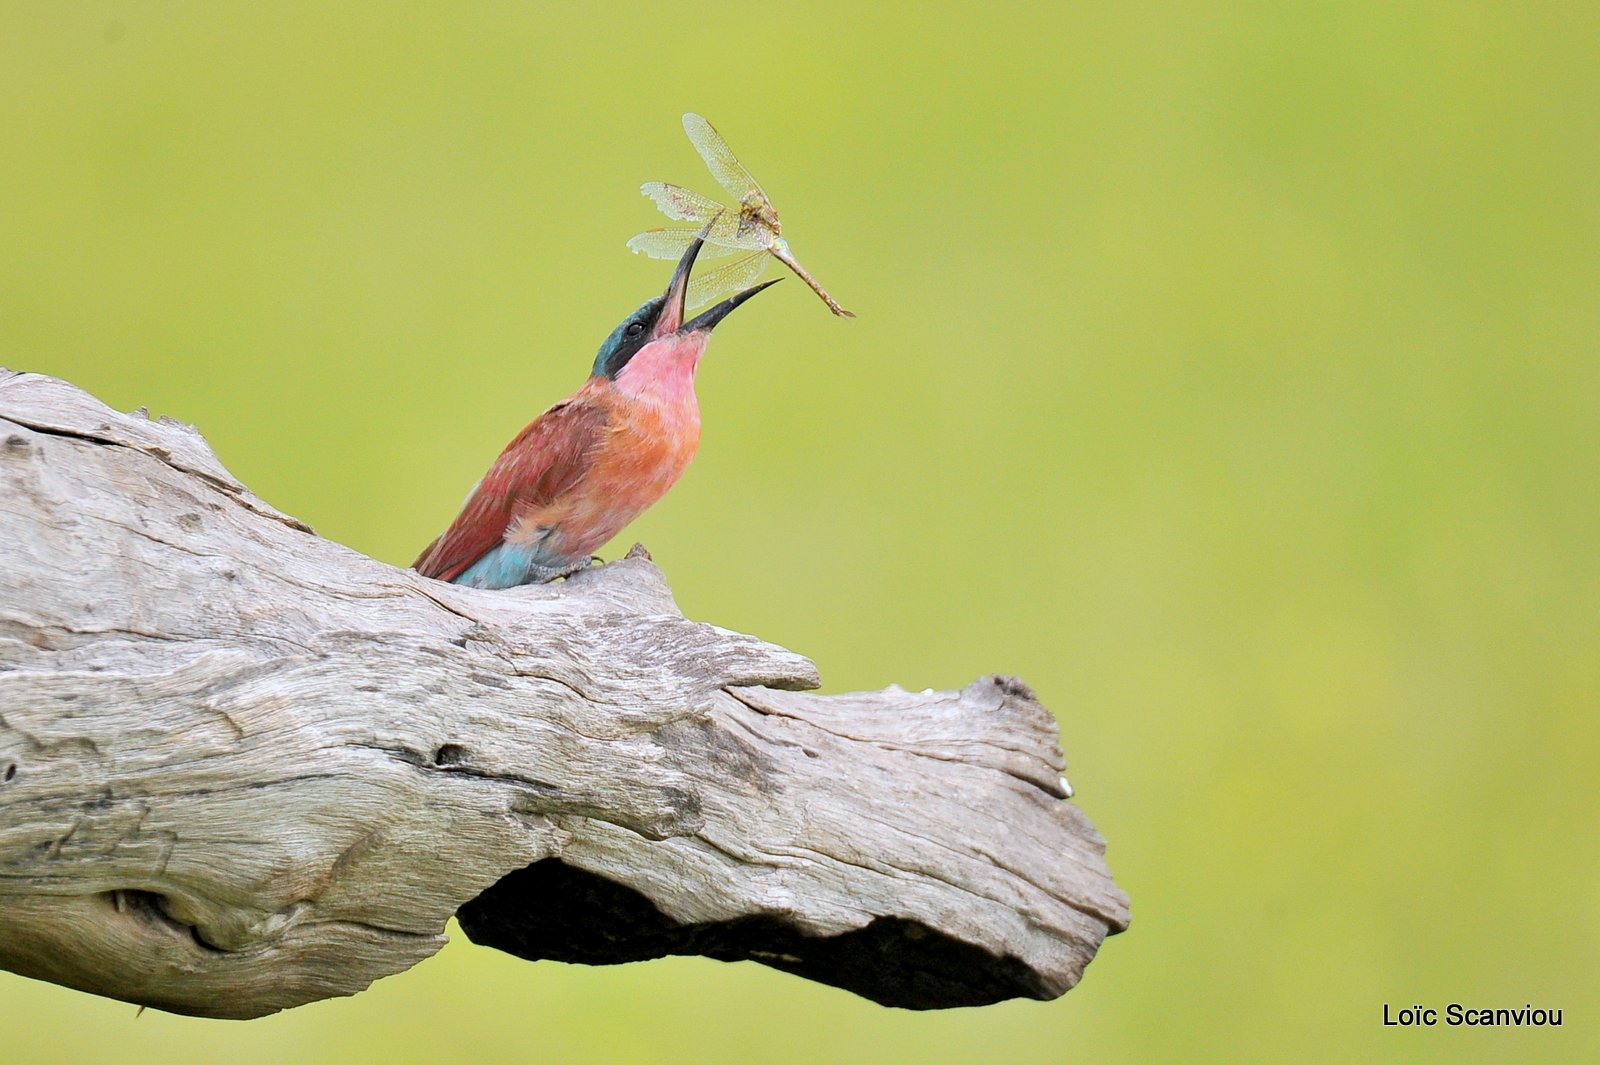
[627,112,856,318]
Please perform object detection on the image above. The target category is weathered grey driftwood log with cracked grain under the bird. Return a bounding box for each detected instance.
[0,371,1128,1017]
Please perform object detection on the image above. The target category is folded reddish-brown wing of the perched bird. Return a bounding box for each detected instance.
[414,398,608,580]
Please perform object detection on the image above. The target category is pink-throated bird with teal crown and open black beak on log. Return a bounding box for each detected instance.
[416,233,774,588]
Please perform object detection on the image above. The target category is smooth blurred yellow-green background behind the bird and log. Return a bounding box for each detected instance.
[0,2,1600,1065]
